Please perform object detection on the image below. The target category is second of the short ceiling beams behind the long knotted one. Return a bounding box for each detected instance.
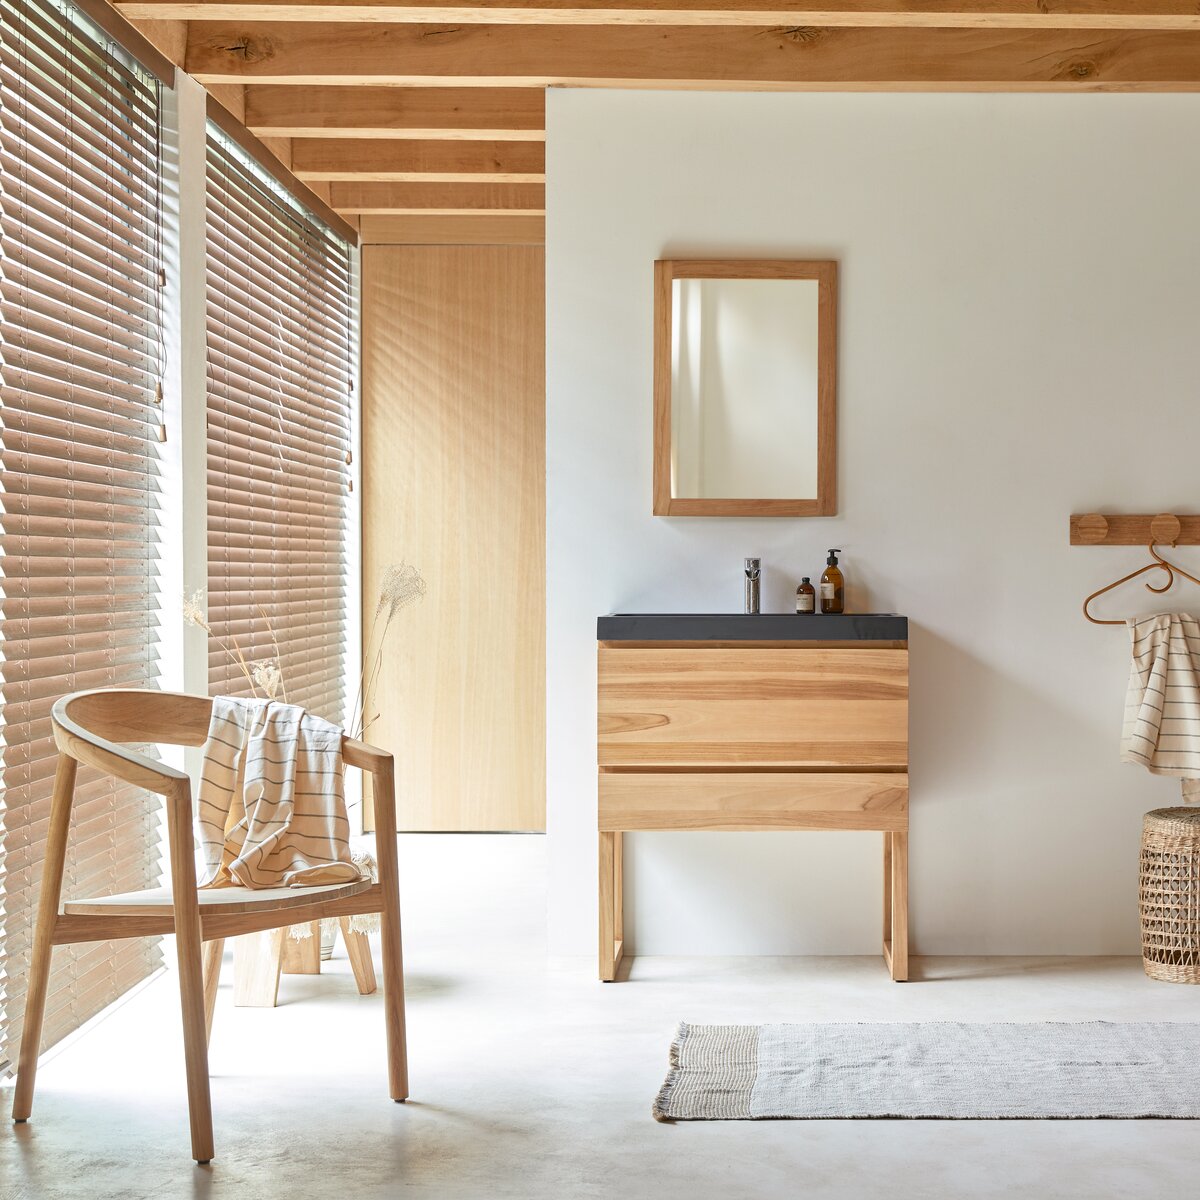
[292,138,546,184]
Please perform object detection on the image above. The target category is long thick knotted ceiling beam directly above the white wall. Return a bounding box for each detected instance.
[186,22,1200,91]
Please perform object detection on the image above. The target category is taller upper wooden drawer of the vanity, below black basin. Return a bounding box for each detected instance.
[598,648,908,768]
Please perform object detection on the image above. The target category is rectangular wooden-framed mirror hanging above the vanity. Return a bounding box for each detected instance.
[654,258,838,517]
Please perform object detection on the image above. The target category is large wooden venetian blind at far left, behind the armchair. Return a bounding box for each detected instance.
[0,0,162,1068]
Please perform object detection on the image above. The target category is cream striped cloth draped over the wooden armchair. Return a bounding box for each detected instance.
[197,696,359,888]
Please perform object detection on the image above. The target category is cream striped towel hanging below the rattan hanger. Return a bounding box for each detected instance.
[1121,612,1200,803]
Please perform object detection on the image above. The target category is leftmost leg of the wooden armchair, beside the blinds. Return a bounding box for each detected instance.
[12,754,77,1121]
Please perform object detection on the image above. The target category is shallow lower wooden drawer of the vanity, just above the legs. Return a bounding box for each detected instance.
[600,770,908,833]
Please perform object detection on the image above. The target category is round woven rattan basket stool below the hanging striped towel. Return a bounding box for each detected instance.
[1139,809,1200,983]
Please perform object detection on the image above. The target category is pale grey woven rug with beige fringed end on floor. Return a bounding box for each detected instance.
[654,1021,1200,1121]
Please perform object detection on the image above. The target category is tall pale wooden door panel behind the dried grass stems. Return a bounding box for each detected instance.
[362,246,546,830]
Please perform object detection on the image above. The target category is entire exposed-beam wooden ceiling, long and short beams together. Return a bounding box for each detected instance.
[115,0,1200,232]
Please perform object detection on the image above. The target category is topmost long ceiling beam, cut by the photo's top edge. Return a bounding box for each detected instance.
[116,0,1200,30]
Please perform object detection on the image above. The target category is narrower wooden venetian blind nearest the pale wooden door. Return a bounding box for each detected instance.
[208,125,354,724]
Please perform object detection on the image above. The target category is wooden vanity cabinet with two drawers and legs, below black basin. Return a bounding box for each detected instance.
[596,643,908,980]
